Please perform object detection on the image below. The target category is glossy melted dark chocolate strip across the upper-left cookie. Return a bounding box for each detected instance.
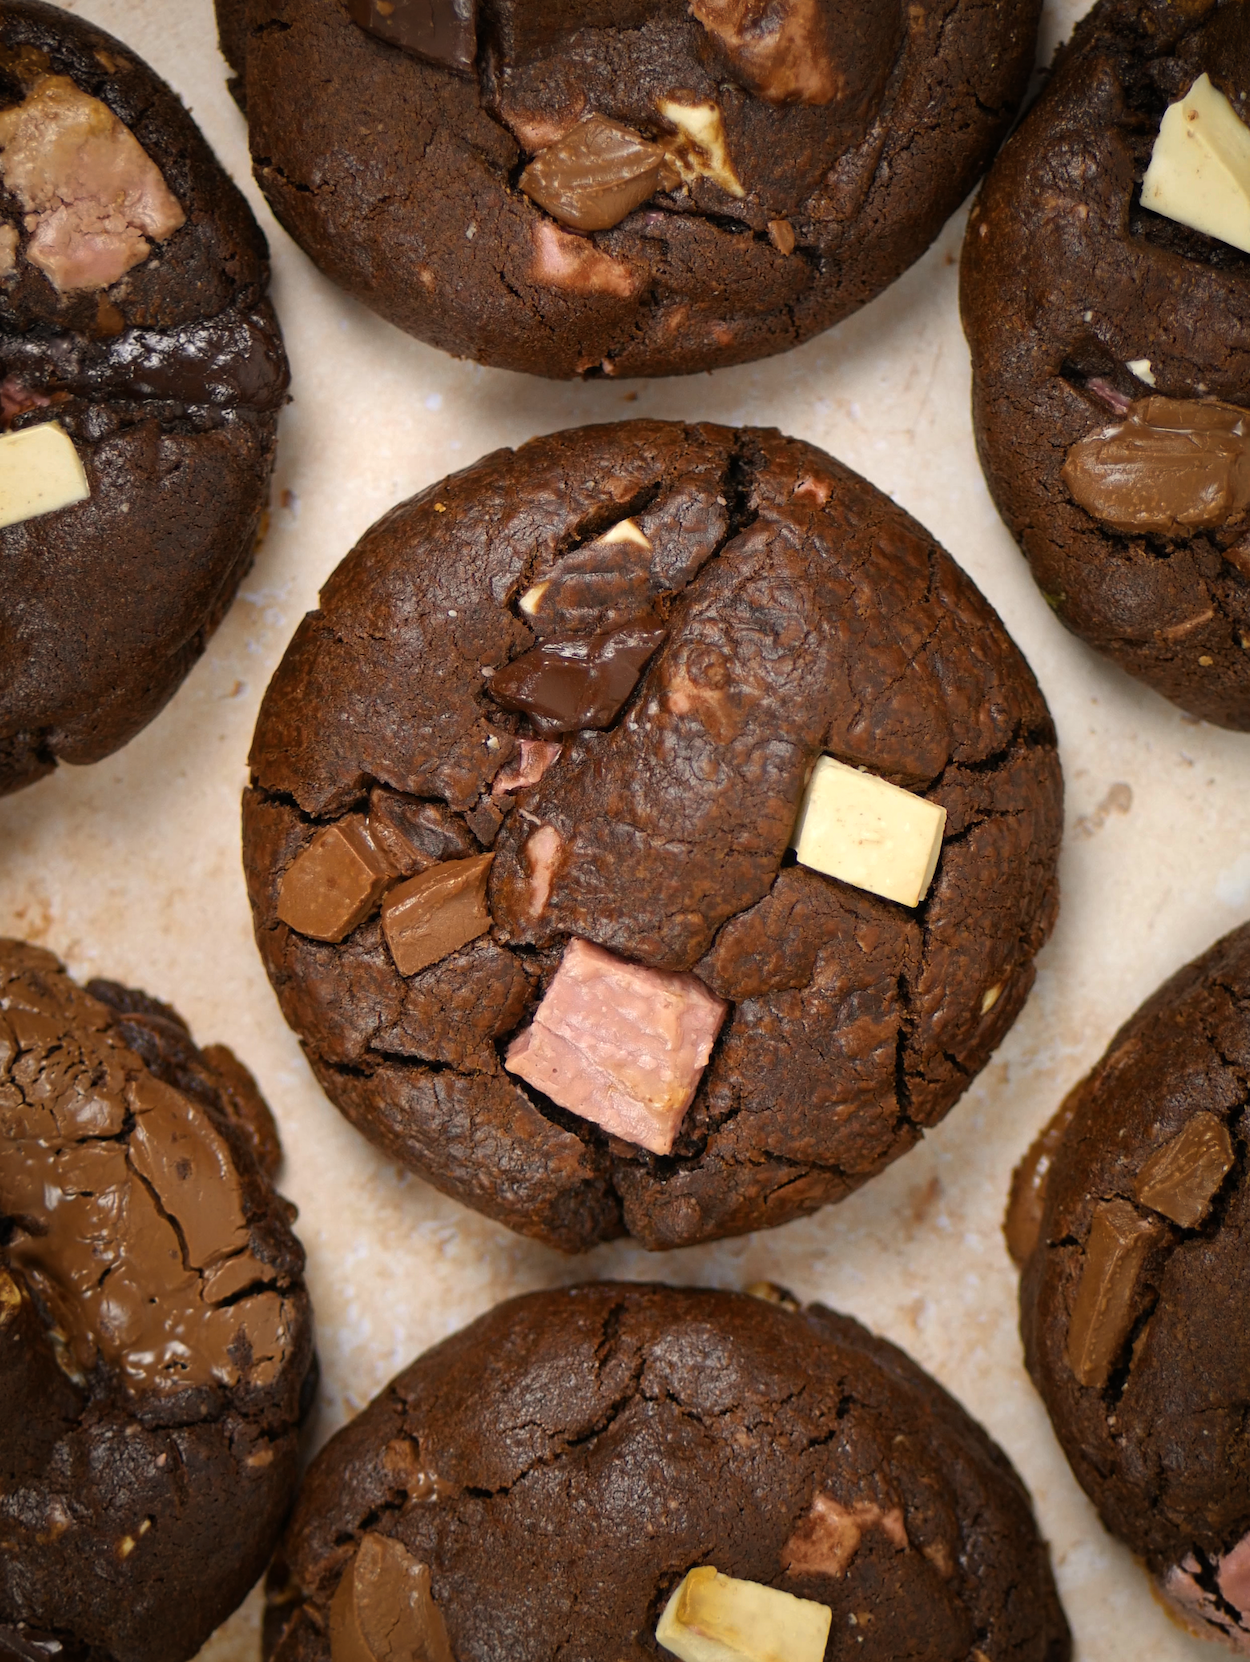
[0,312,289,414]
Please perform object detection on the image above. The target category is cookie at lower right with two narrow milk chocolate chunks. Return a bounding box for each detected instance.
[1007,924,1250,1655]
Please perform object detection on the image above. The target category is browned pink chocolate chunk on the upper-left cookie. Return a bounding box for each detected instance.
[0,75,186,294]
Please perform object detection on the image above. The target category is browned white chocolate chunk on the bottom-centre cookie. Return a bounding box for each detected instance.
[655,1566,833,1662]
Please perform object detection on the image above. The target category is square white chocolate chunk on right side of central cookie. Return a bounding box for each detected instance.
[791,756,946,906]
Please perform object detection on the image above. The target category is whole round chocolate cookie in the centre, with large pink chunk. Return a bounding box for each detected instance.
[243,420,1062,1250]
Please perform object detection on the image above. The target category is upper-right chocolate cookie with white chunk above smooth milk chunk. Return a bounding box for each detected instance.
[962,0,1250,730]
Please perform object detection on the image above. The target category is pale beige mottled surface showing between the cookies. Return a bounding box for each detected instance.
[0,0,1250,1662]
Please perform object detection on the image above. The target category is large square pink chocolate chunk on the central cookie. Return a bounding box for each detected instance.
[504,939,728,1153]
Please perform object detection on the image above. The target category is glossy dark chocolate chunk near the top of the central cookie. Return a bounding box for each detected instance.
[487,623,667,735]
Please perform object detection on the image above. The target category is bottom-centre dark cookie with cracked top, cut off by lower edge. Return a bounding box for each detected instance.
[264,1283,1070,1662]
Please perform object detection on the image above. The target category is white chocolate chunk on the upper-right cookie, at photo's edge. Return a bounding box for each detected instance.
[1142,75,1250,254]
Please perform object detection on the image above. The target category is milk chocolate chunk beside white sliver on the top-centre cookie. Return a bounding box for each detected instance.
[520,115,678,231]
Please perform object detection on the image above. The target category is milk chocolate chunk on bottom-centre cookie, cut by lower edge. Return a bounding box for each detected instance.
[329,1532,455,1662]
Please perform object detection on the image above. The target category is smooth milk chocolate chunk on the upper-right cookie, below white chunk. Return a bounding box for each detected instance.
[1061,397,1250,535]
